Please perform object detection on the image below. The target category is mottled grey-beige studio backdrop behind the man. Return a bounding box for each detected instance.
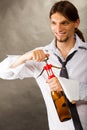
[0,0,87,130]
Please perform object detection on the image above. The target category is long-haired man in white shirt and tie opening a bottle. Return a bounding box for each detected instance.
[0,1,87,130]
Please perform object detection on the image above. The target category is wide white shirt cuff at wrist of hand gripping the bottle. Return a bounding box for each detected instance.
[58,77,79,103]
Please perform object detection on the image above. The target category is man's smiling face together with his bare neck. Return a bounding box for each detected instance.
[50,12,80,58]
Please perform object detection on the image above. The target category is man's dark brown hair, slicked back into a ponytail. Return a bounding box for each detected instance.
[49,0,85,41]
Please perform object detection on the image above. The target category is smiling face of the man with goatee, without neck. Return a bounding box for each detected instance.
[50,13,79,42]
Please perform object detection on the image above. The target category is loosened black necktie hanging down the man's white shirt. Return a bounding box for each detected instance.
[57,51,83,130]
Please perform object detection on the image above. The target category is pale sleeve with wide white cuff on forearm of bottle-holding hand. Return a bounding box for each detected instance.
[58,77,87,102]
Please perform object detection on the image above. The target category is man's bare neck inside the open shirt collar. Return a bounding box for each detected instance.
[56,38,75,59]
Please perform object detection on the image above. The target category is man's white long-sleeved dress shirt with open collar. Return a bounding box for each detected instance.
[0,36,87,130]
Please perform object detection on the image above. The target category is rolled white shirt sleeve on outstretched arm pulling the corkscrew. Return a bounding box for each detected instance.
[0,55,36,80]
